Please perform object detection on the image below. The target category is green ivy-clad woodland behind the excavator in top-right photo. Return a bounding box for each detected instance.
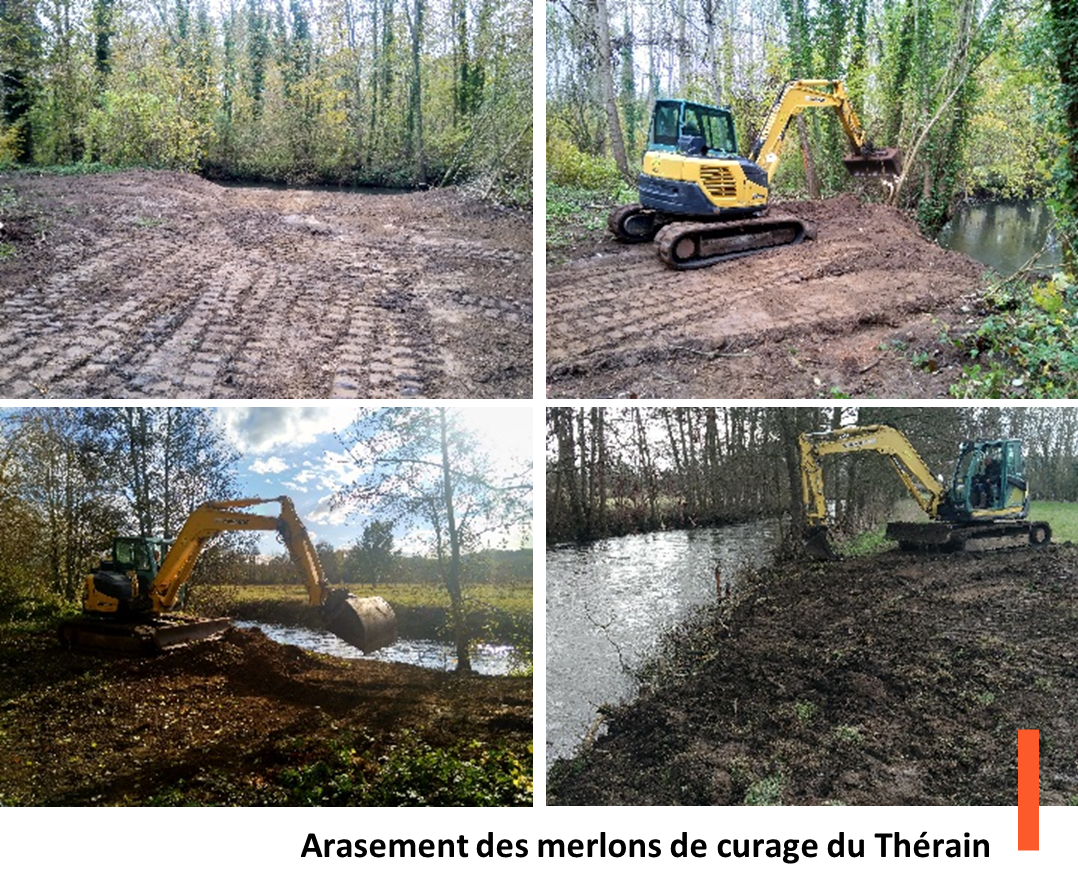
[547,0,1078,260]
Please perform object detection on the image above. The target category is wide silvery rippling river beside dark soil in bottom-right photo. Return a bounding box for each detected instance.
[547,521,779,768]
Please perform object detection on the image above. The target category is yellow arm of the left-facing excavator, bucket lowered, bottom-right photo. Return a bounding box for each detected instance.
[800,426,946,559]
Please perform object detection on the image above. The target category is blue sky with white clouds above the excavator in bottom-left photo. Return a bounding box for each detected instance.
[213,407,533,553]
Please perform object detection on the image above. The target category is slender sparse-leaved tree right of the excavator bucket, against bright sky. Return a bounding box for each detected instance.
[335,407,531,673]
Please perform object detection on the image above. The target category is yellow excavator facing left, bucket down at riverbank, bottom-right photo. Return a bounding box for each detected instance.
[800,426,1052,560]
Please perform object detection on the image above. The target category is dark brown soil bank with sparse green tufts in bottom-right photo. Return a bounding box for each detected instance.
[548,545,1078,806]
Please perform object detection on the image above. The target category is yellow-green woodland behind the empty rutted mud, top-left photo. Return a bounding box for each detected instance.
[0,0,533,205]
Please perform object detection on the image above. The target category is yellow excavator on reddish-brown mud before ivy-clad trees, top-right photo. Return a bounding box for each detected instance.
[608,80,902,271]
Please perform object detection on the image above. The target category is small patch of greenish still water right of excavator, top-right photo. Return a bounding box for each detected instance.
[939,202,1062,276]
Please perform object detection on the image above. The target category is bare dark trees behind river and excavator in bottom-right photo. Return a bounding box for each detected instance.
[545,403,1078,546]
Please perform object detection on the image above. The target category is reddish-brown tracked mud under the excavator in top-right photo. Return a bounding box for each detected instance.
[547,195,983,398]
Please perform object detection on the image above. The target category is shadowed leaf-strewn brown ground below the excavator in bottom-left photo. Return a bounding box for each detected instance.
[0,628,533,807]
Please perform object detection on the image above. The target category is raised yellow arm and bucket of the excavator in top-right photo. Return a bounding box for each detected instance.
[749,80,902,182]
